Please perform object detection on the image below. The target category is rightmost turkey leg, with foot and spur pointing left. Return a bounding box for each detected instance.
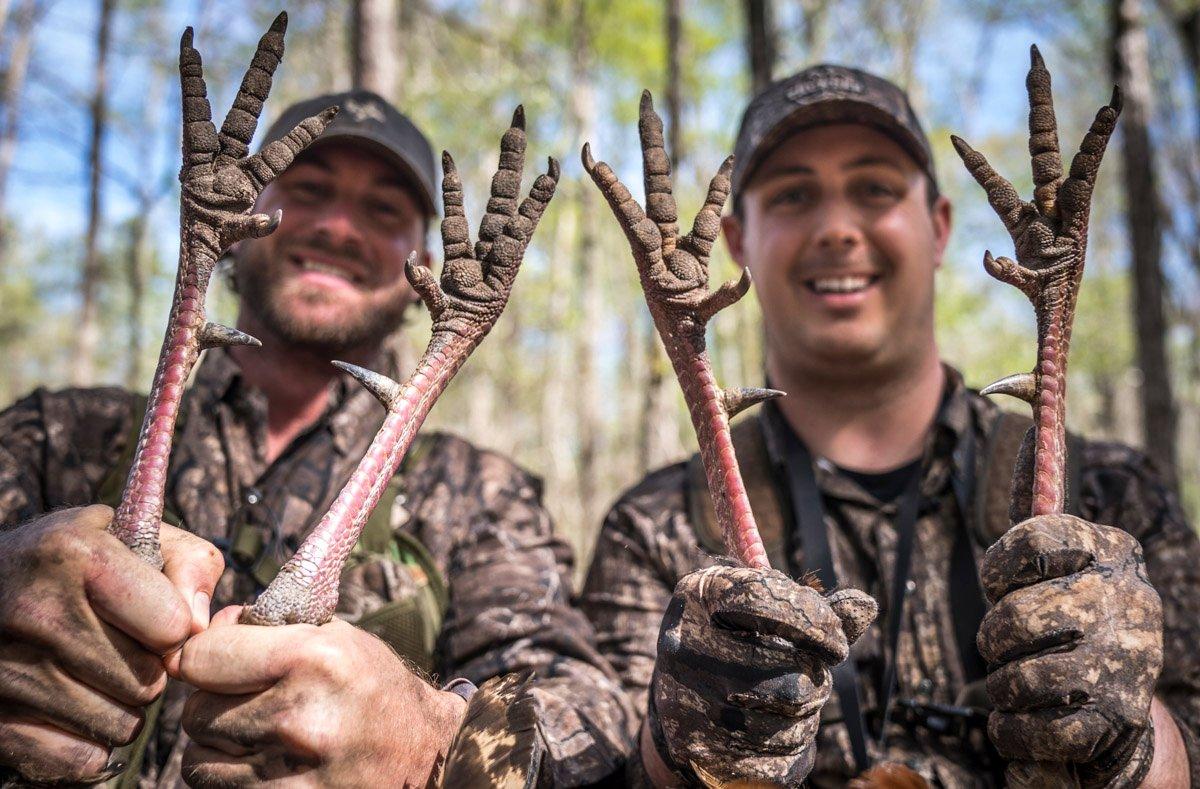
[952,47,1121,516]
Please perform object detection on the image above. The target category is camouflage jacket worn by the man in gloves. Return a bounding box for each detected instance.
[582,371,1200,787]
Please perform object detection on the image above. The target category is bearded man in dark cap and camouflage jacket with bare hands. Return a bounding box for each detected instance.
[0,91,630,785]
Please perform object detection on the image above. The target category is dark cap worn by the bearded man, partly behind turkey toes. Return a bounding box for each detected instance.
[262,90,437,217]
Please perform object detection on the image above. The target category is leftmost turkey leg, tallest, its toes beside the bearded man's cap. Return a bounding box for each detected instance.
[108,13,337,568]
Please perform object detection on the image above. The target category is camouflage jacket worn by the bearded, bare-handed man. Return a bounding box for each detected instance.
[0,350,634,785]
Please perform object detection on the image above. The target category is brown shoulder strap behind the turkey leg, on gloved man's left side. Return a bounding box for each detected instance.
[684,414,788,572]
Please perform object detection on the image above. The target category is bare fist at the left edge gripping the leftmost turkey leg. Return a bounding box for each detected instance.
[0,505,223,783]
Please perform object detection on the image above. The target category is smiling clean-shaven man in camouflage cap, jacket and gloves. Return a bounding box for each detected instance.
[583,66,1200,787]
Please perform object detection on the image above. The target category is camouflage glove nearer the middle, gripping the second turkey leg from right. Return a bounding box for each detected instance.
[649,566,878,785]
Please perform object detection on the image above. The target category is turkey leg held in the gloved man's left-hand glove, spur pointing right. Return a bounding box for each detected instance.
[582,91,782,570]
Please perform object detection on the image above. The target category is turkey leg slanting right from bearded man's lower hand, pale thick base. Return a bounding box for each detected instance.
[241,107,558,625]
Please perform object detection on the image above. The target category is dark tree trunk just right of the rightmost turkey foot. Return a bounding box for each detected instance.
[1111,0,1176,482]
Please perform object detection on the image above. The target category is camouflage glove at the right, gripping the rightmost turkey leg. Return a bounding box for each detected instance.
[978,514,1163,787]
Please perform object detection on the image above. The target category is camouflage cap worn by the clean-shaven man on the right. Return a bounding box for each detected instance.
[733,64,937,199]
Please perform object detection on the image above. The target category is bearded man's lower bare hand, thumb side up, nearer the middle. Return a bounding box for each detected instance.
[180,607,466,787]
